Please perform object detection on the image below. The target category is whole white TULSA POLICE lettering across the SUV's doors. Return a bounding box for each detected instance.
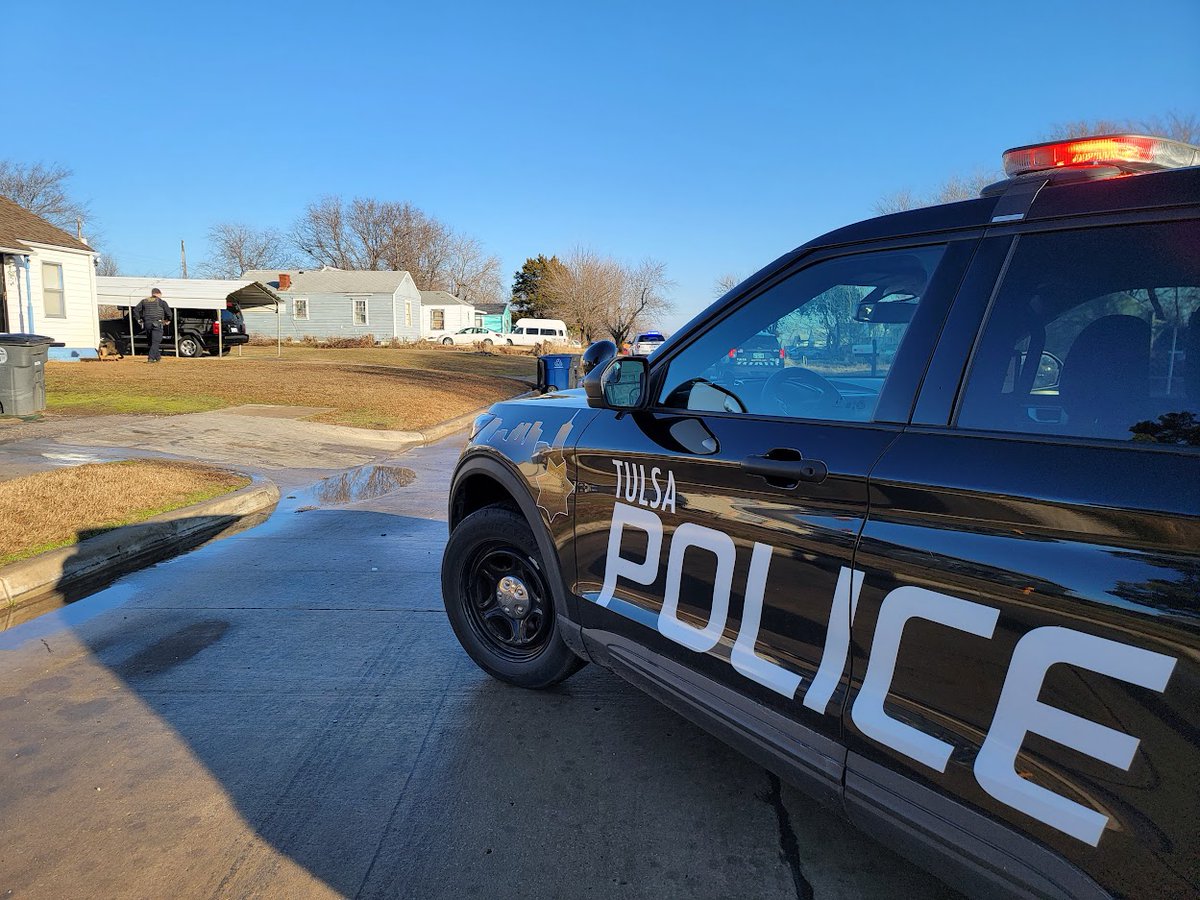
[588,494,1176,846]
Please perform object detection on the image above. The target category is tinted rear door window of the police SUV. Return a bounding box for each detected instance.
[959,222,1200,446]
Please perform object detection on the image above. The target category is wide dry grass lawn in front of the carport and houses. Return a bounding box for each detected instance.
[46,349,532,430]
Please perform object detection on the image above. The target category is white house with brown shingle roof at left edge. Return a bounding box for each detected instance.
[0,197,100,359]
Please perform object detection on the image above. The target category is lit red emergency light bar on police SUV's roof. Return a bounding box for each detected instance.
[1004,134,1200,178]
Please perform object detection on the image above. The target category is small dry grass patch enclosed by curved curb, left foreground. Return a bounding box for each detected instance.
[0,460,250,565]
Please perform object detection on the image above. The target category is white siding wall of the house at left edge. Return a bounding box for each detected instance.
[4,244,100,349]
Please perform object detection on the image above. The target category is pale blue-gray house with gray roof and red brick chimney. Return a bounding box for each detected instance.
[242,266,422,341]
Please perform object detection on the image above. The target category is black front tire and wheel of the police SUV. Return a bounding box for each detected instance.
[442,506,583,689]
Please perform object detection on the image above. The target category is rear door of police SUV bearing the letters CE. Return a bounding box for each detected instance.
[846,221,1200,896]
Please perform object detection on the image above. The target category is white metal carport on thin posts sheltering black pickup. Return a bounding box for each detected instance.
[96,275,283,356]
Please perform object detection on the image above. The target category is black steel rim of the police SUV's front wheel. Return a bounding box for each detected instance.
[462,542,554,661]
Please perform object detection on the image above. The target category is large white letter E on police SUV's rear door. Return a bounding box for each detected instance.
[974,625,1175,847]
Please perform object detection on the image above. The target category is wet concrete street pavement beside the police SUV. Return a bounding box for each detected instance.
[0,439,952,898]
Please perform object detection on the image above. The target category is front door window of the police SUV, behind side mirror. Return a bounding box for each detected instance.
[660,246,944,421]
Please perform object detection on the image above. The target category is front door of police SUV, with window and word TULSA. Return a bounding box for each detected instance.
[575,240,974,796]
